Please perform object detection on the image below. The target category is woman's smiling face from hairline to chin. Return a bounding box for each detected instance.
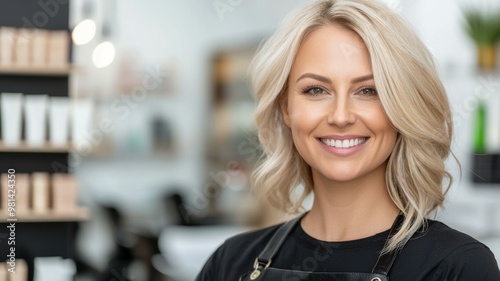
[281,25,397,183]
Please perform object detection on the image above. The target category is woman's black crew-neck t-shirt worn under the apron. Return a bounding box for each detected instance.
[196,220,500,281]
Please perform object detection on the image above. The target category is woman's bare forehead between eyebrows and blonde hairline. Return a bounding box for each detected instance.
[290,25,371,81]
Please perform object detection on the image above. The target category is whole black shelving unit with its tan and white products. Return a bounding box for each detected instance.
[0,0,82,281]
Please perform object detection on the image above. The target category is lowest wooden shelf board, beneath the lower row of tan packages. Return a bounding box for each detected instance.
[0,207,90,223]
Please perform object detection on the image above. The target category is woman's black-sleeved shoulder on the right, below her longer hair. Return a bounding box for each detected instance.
[394,220,500,280]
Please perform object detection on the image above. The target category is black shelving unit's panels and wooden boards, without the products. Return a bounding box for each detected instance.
[0,0,83,281]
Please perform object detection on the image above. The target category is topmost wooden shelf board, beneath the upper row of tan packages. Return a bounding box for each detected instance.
[0,64,74,76]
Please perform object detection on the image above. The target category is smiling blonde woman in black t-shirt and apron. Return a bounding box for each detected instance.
[197,0,500,281]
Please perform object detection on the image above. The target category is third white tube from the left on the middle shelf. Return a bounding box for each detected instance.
[49,97,70,147]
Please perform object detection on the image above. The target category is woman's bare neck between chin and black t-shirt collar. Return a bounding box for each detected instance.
[301,163,399,241]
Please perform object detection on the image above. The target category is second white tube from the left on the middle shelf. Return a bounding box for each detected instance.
[24,95,47,147]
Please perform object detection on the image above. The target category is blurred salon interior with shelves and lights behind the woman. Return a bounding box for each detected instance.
[0,0,500,281]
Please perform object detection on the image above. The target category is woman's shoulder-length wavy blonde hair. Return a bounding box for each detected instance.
[251,0,452,251]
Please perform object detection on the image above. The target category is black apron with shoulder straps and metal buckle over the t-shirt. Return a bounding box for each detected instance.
[240,214,404,281]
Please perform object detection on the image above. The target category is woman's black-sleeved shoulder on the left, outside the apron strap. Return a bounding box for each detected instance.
[196,221,283,281]
